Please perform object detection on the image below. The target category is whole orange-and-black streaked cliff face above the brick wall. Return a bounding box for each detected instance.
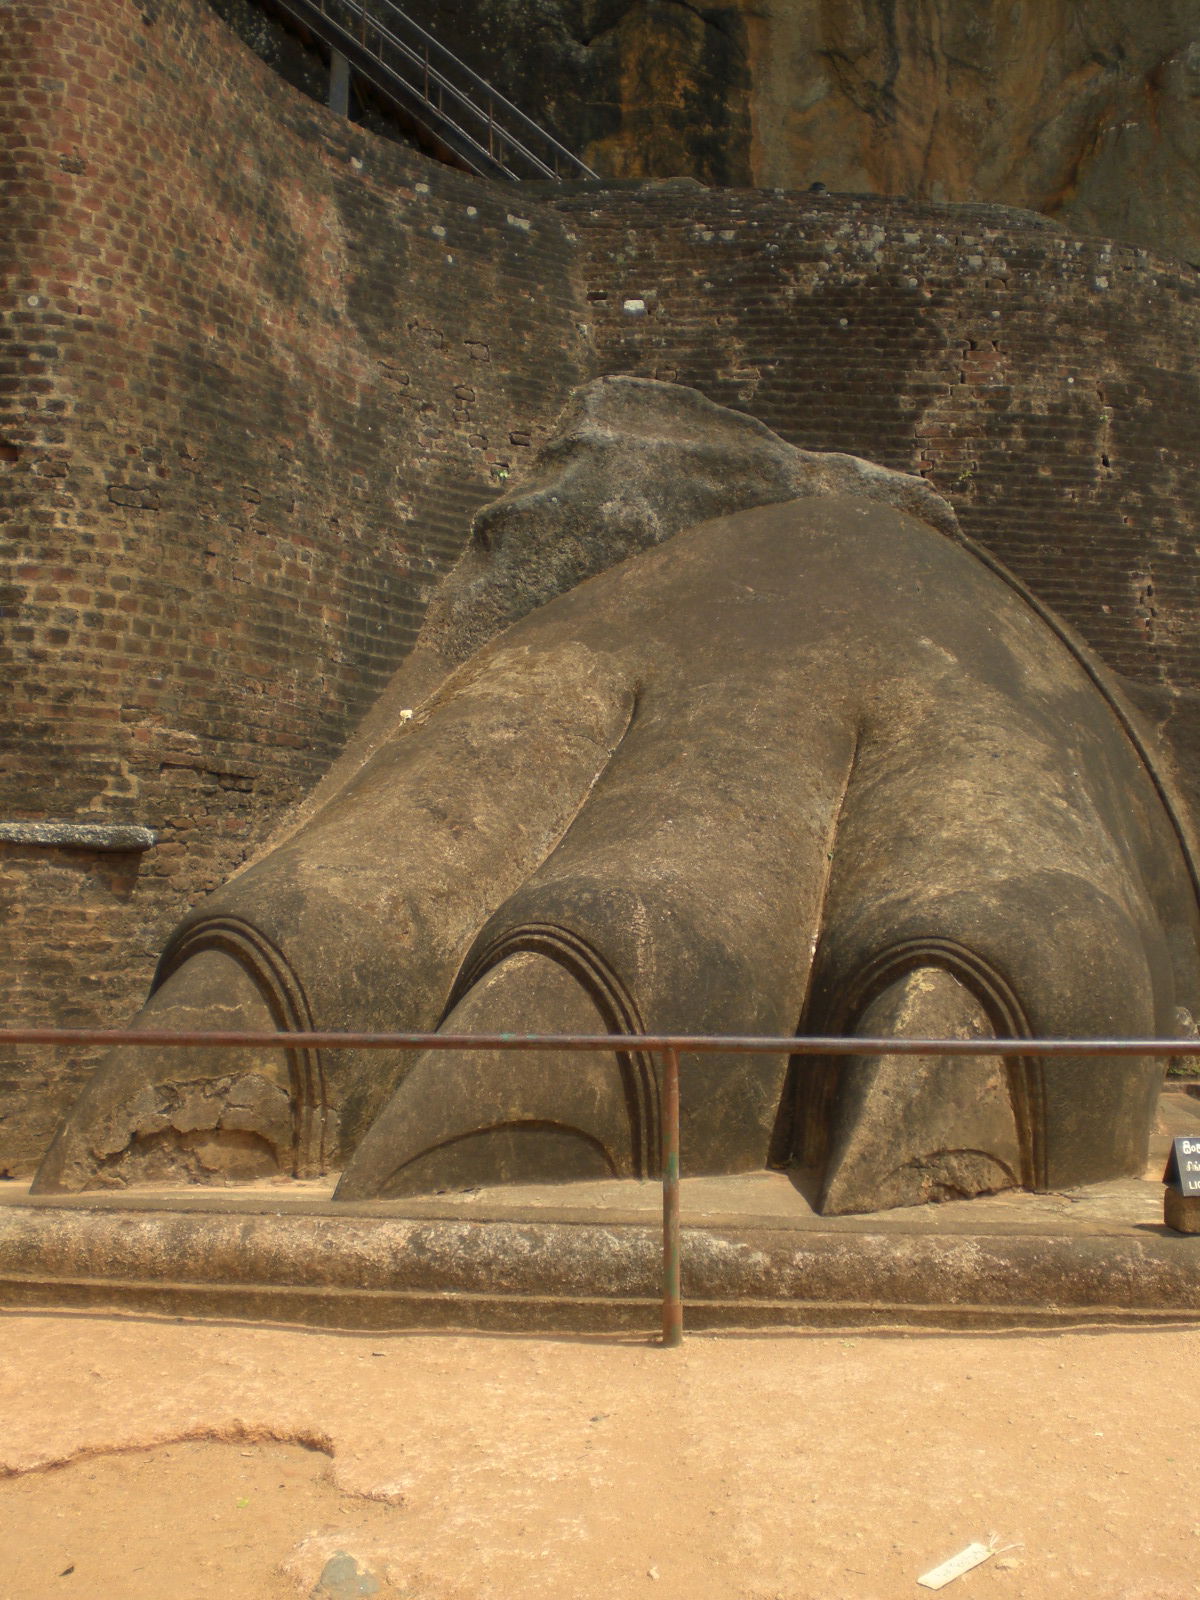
[400,0,1200,259]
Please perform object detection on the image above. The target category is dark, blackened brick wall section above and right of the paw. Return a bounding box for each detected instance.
[558,187,1200,690]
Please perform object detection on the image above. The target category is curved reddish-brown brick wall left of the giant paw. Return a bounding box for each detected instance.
[0,0,582,1170]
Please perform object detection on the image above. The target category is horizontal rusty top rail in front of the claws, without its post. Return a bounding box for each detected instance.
[0,1027,1200,1056]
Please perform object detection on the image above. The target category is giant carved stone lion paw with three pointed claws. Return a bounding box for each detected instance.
[35,379,1200,1211]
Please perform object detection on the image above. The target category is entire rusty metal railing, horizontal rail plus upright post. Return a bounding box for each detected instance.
[0,1027,1200,1349]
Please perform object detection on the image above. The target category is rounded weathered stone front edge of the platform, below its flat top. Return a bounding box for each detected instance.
[0,1203,1200,1334]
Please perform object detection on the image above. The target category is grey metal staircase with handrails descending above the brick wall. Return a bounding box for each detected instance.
[272,0,597,182]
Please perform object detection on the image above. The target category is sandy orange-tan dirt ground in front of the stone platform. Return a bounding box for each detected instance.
[0,1314,1200,1600]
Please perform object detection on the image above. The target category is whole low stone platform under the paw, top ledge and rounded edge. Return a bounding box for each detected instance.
[0,1157,1200,1334]
